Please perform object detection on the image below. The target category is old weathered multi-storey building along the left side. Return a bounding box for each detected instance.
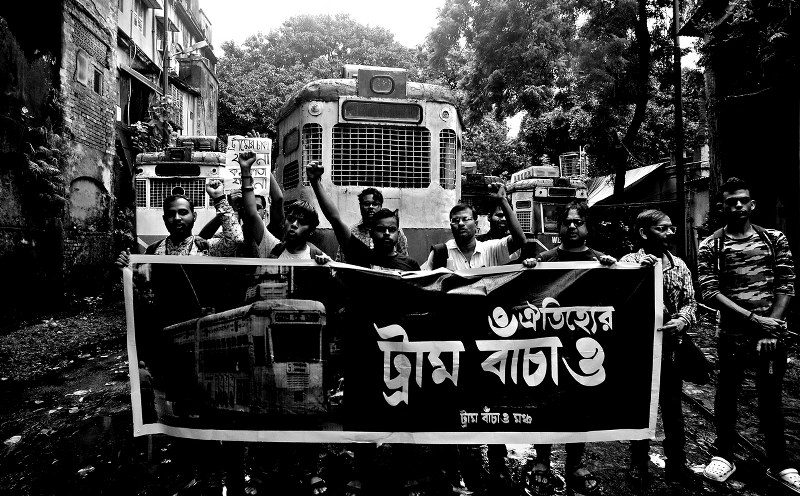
[0,0,218,313]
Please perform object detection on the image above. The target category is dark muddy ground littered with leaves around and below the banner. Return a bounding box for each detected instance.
[0,299,800,496]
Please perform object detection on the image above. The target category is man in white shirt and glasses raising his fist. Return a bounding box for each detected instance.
[422,183,525,270]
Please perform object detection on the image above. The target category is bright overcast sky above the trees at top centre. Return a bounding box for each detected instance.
[200,0,444,57]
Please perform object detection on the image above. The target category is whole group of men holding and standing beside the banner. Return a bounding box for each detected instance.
[118,148,800,495]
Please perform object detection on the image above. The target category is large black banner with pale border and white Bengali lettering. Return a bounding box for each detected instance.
[125,256,662,444]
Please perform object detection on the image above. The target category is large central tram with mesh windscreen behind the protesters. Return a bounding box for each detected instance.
[275,65,462,260]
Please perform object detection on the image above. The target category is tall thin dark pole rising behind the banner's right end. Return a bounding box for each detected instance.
[672,0,690,258]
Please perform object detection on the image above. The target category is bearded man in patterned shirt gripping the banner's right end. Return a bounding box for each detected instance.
[620,210,697,489]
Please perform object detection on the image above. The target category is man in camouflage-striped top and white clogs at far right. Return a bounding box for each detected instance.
[697,177,800,492]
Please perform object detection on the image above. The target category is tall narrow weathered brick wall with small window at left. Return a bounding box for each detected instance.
[60,0,119,294]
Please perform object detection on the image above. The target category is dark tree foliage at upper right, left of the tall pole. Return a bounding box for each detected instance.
[429,0,698,184]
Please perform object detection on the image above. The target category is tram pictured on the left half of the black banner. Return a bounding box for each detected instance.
[164,299,327,416]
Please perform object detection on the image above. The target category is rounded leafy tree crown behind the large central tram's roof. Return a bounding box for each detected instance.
[212,14,425,134]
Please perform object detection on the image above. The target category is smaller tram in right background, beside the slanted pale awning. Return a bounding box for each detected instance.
[508,165,588,250]
